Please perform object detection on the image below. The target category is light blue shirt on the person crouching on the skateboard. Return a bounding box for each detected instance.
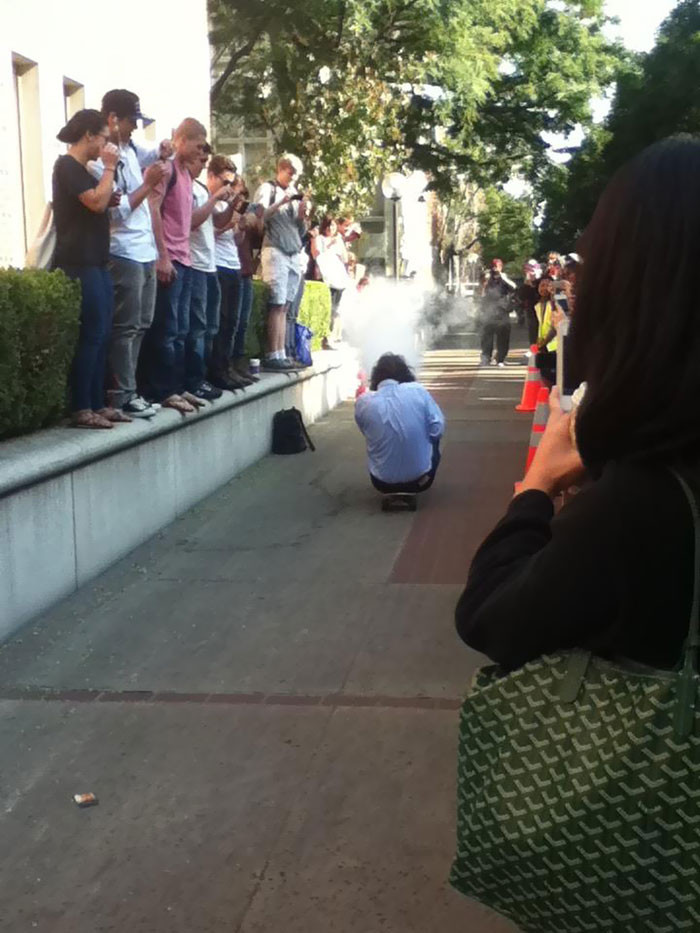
[355,379,445,483]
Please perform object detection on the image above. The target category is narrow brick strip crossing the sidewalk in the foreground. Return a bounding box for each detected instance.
[0,687,462,710]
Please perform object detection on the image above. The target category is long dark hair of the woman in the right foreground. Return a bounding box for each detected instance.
[571,136,700,469]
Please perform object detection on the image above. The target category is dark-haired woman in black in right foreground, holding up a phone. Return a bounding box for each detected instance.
[456,136,700,670]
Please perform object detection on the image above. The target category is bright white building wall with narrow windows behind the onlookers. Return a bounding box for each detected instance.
[0,0,210,267]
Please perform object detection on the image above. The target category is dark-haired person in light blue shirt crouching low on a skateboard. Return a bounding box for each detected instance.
[355,353,445,495]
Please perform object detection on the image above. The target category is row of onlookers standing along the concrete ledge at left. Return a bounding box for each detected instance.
[47,89,364,428]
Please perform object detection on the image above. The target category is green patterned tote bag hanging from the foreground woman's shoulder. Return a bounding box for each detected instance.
[450,473,700,933]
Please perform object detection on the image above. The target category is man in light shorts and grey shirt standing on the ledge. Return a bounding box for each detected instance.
[255,155,306,373]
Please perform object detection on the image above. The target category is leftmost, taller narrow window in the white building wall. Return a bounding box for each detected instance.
[12,54,46,249]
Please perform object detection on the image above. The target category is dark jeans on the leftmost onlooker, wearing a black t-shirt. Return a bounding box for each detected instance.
[62,266,114,411]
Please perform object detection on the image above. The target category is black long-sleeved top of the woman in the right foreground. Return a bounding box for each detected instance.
[456,464,700,669]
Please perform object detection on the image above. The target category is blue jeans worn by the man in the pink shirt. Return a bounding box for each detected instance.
[148,262,191,402]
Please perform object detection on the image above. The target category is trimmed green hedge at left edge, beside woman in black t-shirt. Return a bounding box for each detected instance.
[0,269,80,439]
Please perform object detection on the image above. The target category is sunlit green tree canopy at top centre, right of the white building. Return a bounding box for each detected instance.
[210,0,621,212]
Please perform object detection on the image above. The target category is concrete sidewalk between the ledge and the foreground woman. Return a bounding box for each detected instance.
[0,342,530,933]
